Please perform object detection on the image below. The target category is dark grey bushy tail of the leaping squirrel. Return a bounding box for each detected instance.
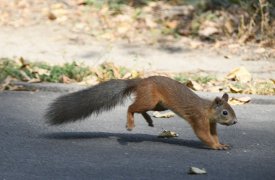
[45,79,139,125]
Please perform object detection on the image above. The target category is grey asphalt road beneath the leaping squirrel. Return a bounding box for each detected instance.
[0,92,275,180]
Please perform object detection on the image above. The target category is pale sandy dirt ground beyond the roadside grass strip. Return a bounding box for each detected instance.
[0,0,275,78]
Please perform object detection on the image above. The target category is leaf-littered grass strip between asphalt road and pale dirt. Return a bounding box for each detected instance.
[0,58,275,95]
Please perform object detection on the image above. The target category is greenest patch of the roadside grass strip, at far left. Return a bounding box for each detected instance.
[0,58,91,82]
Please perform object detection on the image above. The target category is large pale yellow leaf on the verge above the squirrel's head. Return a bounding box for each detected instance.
[226,67,252,83]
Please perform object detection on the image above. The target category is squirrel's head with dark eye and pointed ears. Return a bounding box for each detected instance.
[210,93,237,126]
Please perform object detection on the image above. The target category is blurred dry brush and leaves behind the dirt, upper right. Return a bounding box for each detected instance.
[83,0,275,46]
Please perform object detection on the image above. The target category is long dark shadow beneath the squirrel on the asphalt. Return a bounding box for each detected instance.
[42,132,206,149]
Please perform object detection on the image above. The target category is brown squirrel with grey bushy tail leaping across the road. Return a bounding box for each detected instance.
[46,76,237,150]
